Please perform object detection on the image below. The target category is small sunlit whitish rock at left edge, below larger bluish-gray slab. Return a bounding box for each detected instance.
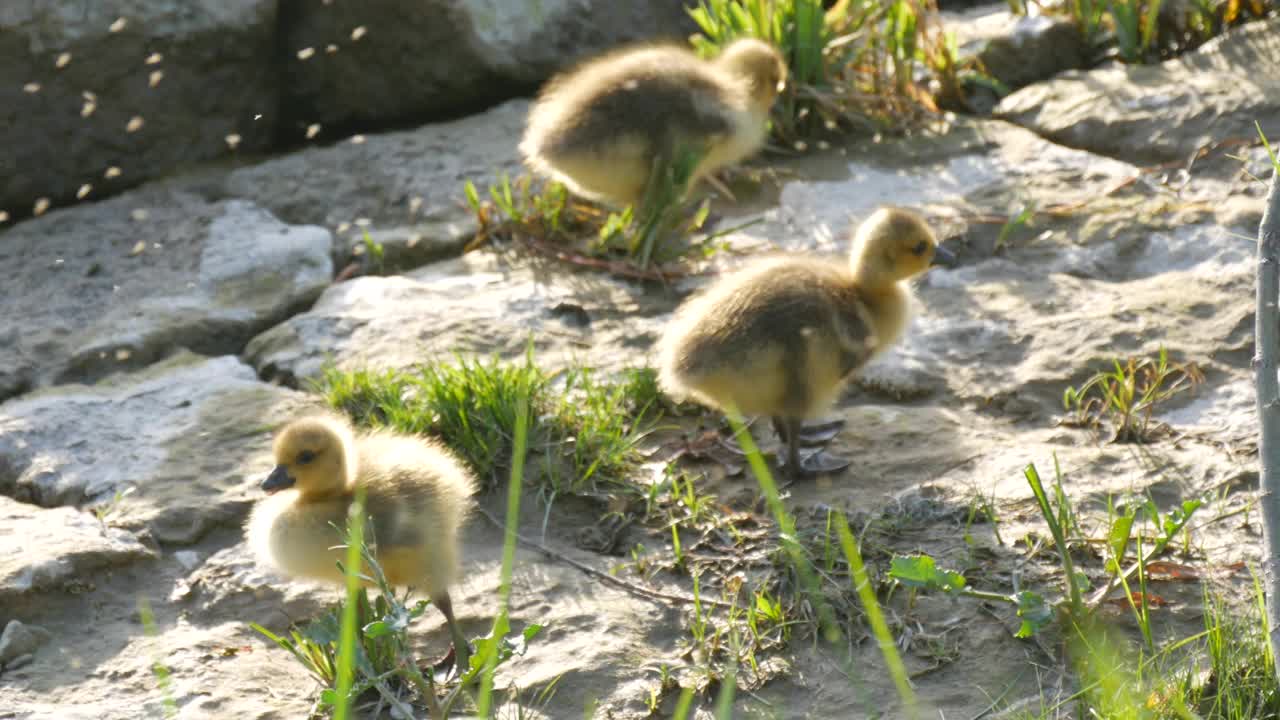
[0,496,151,597]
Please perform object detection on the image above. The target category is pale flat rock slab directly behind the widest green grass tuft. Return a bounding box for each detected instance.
[244,252,675,380]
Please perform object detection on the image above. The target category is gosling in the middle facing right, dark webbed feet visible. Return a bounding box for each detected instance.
[659,208,954,479]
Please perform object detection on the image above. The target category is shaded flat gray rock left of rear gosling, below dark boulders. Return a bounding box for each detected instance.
[221,100,529,270]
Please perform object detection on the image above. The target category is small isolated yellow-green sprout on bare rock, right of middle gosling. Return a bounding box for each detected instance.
[1062,348,1204,442]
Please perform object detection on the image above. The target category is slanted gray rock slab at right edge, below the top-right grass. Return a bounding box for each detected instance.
[996,18,1280,164]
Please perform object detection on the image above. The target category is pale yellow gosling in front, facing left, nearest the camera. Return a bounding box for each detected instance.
[246,415,476,669]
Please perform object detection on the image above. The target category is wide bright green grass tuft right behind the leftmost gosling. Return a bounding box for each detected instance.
[320,352,662,493]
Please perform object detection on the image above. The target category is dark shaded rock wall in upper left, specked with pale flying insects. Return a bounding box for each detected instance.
[0,0,695,218]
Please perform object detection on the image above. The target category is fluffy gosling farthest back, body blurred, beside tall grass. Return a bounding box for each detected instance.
[520,38,787,205]
